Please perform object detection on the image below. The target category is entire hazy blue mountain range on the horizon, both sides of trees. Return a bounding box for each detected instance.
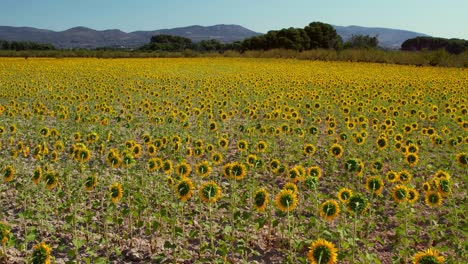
[0,24,427,49]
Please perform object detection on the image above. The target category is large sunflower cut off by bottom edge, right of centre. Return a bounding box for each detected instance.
[307,239,338,264]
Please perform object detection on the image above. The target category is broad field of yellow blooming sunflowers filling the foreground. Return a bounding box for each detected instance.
[0,58,468,264]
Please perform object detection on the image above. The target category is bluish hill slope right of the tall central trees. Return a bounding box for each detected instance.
[333,26,428,49]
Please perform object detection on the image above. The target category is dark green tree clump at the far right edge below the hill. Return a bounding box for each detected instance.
[401,37,468,54]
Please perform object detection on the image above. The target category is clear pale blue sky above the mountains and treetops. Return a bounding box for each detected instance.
[0,0,468,39]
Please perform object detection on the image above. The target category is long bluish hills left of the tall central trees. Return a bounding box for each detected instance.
[0,25,260,48]
